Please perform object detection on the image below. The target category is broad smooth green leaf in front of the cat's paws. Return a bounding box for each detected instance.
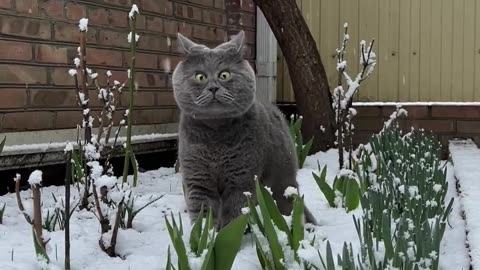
[215,215,248,269]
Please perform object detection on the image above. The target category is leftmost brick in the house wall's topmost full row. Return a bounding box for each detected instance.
[0,16,51,39]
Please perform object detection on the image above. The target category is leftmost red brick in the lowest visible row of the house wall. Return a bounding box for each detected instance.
[2,111,55,132]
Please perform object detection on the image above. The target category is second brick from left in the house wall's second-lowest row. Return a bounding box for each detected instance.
[30,89,78,108]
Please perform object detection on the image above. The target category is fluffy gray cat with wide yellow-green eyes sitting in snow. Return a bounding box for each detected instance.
[173,31,315,228]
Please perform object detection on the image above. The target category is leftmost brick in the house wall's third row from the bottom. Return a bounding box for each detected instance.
[0,65,47,85]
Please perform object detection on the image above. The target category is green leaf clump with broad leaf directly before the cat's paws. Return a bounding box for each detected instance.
[165,206,248,270]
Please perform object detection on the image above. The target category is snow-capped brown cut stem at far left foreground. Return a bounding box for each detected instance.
[14,170,50,264]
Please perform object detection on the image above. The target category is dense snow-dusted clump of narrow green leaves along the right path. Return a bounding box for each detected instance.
[354,122,453,270]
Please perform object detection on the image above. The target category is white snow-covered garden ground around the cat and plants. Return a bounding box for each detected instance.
[0,150,470,270]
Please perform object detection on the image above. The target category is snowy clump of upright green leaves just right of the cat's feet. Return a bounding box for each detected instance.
[244,180,326,270]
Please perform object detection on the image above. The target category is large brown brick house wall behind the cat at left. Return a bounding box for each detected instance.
[0,0,255,132]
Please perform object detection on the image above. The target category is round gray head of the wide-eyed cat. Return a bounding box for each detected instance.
[172,31,255,119]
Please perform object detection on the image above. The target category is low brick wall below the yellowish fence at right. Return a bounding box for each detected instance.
[354,105,480,158]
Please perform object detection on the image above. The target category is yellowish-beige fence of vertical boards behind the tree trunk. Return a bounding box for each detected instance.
[277,0,480,102]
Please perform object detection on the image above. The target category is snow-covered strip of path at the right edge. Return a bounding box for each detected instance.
[449,140,480,269]
